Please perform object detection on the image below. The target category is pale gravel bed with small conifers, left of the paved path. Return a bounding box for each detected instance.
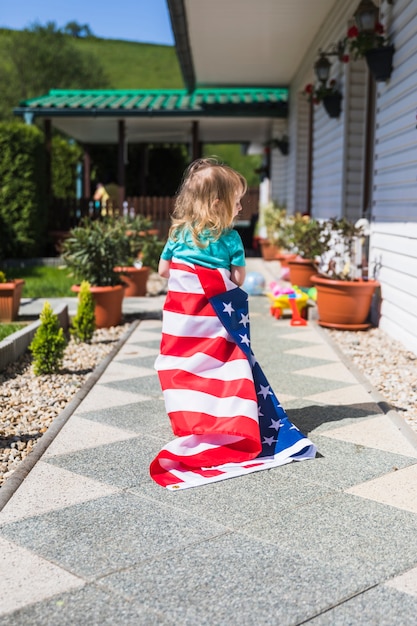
[0,324,130,486]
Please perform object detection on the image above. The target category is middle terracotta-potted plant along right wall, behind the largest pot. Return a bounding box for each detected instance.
[283,213,330,287]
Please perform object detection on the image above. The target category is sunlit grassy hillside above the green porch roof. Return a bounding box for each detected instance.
[74,37,184,89]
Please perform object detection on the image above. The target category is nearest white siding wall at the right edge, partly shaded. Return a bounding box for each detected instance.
[370,0,417,354]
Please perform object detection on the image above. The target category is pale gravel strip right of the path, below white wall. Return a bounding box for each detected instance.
[326,328,417,433]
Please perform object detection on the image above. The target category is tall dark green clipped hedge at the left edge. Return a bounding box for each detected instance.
[0,122,47,258]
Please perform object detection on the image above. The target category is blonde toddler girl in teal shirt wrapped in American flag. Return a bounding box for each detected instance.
[150,159,316,489]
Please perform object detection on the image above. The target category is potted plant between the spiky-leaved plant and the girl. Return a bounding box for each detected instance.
[114,215,164,297]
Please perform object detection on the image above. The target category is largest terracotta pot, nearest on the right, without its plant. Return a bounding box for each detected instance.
[311,276,379,330]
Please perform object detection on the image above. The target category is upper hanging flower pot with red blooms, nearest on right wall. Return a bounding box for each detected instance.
[345,22,395,82]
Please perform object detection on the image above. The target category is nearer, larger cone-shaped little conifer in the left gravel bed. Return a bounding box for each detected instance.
[29,301,66,376]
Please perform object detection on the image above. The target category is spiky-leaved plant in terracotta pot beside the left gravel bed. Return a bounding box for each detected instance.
[62,218,126,328]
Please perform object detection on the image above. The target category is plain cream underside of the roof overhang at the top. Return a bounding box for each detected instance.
[167,0,340,89]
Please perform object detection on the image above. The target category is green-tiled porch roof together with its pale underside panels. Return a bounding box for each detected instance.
[14,88,288,143]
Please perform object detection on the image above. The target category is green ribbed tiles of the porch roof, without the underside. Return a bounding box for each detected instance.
[14,87,288,117]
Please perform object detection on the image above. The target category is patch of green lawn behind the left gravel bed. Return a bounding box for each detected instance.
[7,265,75,298]
